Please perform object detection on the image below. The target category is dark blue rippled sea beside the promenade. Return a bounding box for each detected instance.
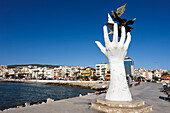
[0,83,95,110]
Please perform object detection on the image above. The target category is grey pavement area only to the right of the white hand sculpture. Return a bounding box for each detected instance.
[130,83,170,113]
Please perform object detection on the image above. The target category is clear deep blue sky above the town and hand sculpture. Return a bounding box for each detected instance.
[0,0,170,70]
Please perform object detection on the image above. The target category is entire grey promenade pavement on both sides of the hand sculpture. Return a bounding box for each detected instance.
[2,83,170,113]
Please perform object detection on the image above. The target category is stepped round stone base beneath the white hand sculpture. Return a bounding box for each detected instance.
[91,99,152,113]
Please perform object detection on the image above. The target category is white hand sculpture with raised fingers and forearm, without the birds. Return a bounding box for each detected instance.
[95,23,132,101]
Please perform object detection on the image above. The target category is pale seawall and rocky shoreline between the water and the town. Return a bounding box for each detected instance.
[0,79,110,91]
